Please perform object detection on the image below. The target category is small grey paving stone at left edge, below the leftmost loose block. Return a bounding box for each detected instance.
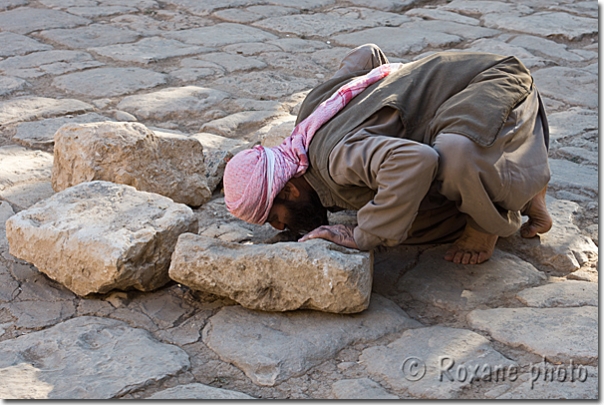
[0,301,75,328]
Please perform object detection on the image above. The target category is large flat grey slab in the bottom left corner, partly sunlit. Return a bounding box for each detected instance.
[0,316,190,399]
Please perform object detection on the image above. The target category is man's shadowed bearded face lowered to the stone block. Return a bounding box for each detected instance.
[267,194,329,235]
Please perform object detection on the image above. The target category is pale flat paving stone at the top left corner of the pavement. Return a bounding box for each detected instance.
[0,7,91,34]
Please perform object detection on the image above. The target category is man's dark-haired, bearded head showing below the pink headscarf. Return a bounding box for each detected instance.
[267,177,329,234]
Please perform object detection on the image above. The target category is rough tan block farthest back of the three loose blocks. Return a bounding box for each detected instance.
[52,122,212,207]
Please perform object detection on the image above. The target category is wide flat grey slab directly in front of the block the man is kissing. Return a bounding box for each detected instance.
[202,294,421,386]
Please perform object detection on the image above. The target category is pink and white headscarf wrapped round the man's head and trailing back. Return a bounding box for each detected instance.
[223,63,402,224]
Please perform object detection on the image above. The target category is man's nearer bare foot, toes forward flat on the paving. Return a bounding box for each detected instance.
[445,225,499,264]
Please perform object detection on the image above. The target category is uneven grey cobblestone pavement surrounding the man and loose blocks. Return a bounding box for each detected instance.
[0,0,598,399]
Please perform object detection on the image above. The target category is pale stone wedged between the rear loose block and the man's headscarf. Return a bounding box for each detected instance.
[191,132,247,191]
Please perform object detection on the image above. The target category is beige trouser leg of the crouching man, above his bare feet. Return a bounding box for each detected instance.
[433,91,550,237]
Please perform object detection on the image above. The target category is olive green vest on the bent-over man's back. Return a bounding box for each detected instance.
[296,52,533,209]
